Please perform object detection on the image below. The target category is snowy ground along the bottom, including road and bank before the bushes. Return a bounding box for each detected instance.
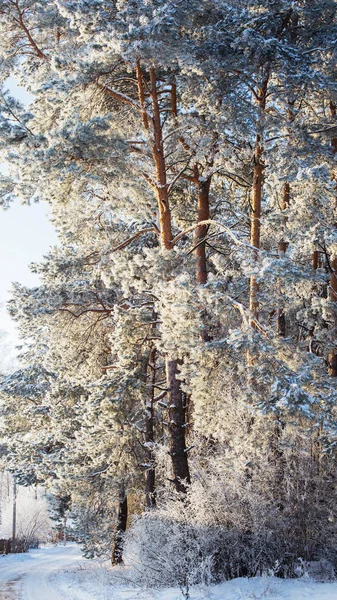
[0,545,337,600]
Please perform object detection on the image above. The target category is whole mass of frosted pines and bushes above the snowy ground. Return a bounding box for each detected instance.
[0,0,337,586]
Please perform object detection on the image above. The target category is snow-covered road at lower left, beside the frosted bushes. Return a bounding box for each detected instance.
[0,544,86,600]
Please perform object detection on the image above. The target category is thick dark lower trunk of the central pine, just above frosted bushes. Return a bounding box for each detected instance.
[166,358,191,493]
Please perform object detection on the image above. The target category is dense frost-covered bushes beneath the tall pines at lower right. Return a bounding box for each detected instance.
[125,439,336,589]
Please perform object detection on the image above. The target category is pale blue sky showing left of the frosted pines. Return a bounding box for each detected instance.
[0,78,56,342]
